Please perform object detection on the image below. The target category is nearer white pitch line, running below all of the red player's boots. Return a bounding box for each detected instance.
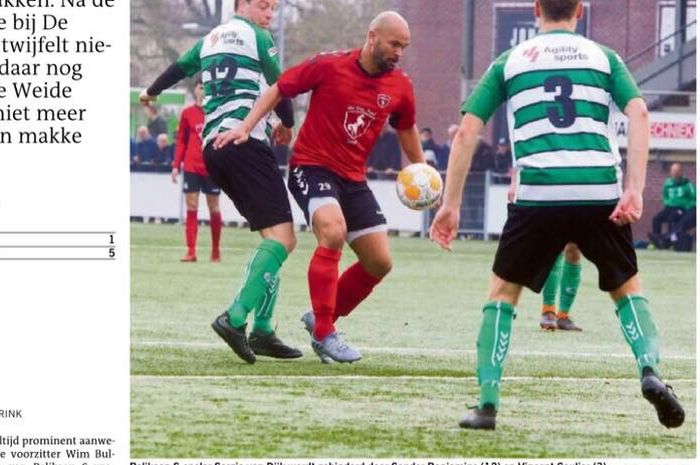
[131,375,696,383]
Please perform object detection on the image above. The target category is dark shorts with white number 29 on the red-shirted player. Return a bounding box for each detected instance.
[287,166,386,242]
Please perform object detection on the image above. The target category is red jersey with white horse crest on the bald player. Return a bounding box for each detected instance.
[277,49,416,181]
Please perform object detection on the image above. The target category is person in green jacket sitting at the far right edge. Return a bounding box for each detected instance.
[649,163,695,249]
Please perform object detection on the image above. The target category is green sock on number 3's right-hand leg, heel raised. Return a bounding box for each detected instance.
[616,295,660,378]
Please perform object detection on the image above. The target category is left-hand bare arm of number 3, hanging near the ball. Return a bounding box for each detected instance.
[430,113,484,250]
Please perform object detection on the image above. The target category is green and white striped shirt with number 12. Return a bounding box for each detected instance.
[177,16,280,146]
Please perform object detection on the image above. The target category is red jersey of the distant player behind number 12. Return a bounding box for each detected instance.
[173,105,209,176]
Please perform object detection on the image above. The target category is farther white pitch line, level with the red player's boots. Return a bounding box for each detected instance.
[131,341,695,360]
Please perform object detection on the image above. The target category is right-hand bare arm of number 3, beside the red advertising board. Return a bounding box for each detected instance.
[610,98,649,226]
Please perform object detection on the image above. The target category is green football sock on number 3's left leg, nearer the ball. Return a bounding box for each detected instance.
[476,301,515,410]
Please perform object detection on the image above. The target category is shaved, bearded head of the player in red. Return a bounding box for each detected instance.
[363,11,411,72]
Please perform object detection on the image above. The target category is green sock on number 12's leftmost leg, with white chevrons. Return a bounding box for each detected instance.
[228,239,287,328]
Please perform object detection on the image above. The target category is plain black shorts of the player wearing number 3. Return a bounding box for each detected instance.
[493,204,638,292]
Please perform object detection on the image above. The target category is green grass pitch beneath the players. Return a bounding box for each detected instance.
[131,225,696,458]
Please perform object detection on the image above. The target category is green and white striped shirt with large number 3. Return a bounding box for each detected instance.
[462,30,641,206]
